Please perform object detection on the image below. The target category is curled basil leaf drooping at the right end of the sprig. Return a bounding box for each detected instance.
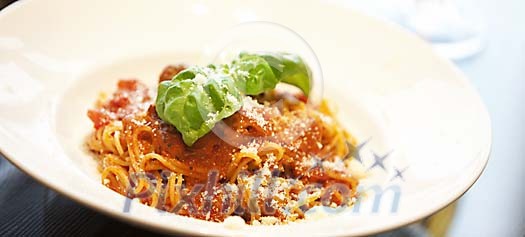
[240,52,311,96]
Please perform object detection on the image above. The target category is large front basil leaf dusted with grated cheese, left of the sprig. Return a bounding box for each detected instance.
[156,67,242,146]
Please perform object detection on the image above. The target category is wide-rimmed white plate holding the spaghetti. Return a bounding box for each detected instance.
[0,0,491,236]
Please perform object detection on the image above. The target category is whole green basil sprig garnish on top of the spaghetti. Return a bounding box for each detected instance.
[156,53,310,146]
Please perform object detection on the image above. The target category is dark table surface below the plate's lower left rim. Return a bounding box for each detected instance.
[0,156,165,236]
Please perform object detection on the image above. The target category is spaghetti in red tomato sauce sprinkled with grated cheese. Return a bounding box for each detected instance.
[87,66,358,224]
